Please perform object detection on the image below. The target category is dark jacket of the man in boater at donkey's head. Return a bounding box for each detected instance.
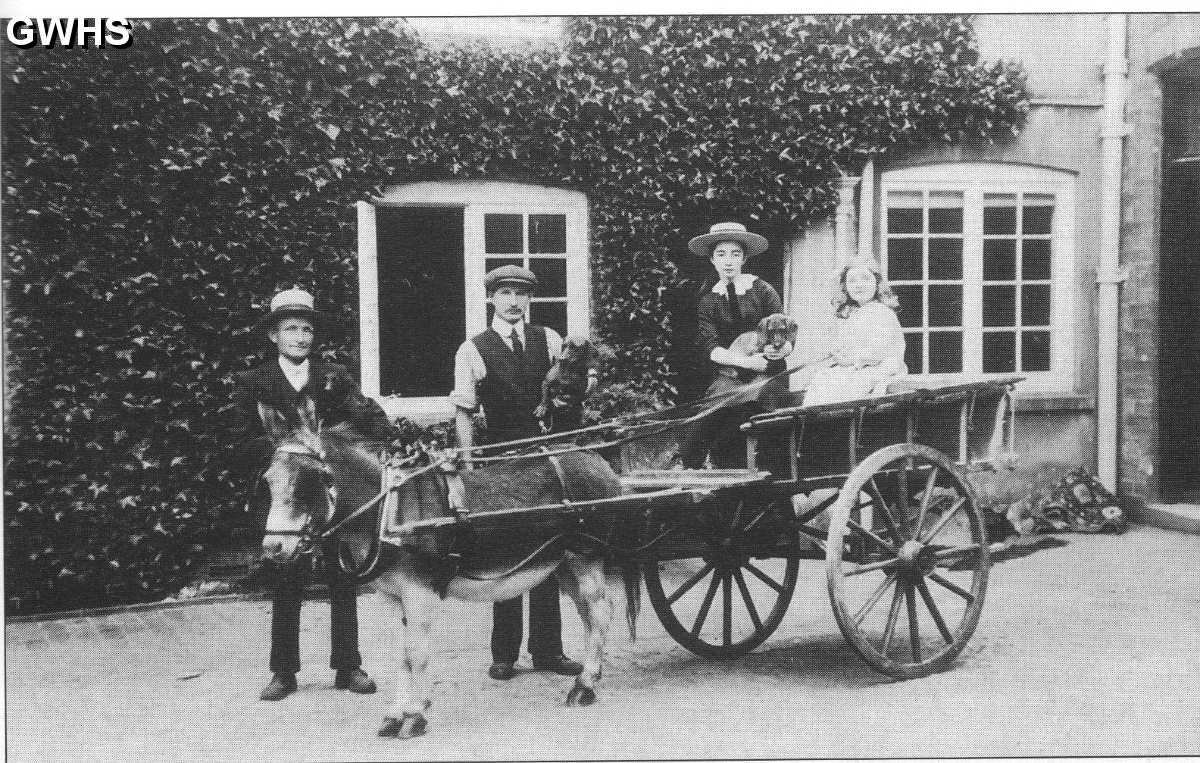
[230,356,398,474]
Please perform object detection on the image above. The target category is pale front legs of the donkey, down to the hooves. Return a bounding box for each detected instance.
[379,583,438,739]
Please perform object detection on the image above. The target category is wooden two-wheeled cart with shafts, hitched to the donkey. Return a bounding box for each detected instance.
[384,377,1020,678]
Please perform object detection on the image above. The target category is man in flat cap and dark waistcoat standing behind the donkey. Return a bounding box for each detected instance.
[450,265,583,680]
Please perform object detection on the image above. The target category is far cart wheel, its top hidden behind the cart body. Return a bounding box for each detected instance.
[643,503,799,657]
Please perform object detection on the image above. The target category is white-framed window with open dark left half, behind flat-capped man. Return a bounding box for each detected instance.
[359,181,590,423]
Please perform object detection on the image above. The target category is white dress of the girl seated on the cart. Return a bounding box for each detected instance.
[804,300,907,405]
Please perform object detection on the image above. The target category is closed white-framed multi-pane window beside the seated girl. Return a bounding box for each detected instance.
[880,162,1076,392]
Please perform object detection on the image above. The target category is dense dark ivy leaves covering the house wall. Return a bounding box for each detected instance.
[2,17,1027,612]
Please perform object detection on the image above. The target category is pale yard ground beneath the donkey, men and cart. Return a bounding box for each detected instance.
[6,528,1200,762]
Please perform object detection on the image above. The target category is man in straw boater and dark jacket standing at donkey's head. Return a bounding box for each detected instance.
[224,289,398,701]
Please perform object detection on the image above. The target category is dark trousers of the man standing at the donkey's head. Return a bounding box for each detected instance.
[271,557,362,673]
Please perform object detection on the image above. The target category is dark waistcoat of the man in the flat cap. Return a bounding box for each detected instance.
[472,325,550,443]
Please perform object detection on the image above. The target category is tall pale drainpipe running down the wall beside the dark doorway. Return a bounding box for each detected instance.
[1096,13,1130,494]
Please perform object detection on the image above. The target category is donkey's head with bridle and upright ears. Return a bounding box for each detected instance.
[258,401,337,563]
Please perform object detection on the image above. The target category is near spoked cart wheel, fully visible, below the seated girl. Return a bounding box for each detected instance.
[826,444,990,678]
